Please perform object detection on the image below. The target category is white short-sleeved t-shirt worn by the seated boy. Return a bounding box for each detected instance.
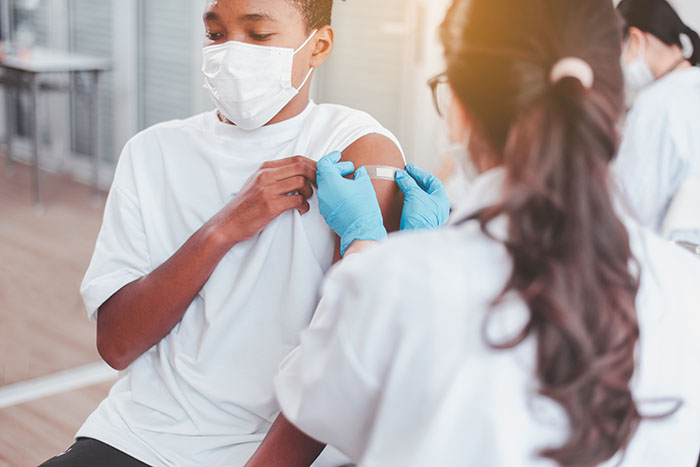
[76,102,398,467]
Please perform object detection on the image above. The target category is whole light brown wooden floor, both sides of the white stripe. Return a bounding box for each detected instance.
[0,157,111,467]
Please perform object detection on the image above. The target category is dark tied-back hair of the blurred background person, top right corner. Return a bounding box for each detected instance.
[617,0,700,66]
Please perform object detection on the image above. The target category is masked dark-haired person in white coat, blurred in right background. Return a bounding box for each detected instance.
[614,0,700,238]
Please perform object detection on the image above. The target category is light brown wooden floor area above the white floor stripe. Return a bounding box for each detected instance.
[0,159,104,386]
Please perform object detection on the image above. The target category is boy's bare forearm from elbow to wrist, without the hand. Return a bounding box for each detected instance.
[97,220,235,370]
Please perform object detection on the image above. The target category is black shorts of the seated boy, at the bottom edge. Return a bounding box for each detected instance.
[41,438,148,467]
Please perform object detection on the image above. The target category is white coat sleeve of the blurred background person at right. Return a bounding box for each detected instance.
[613,99,687,231]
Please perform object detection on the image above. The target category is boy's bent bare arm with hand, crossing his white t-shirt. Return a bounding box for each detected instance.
[97,157,316,370]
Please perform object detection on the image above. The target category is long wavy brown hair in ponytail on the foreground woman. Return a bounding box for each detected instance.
[441,0,641,466]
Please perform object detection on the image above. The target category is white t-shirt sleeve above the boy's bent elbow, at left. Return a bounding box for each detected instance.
[80,144,151,321]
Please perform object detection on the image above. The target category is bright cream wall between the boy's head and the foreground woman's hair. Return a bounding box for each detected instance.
[315,0,449,170]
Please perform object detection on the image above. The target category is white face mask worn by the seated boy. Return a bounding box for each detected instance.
[202,30,317,131]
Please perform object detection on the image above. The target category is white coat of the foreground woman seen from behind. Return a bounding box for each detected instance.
[275,170,700,467]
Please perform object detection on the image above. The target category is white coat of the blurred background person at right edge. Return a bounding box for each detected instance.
[613,67,700,233]
